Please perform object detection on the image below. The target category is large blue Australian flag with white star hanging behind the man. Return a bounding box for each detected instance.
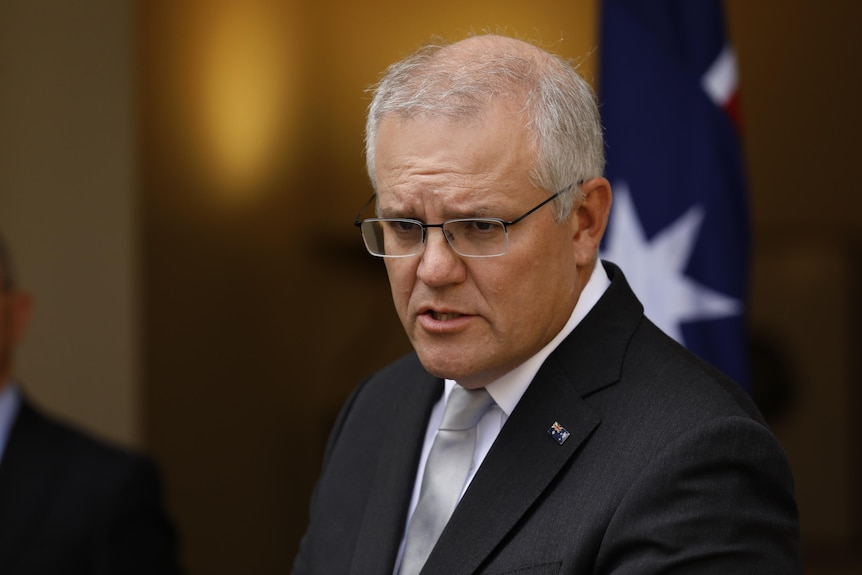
[599,0,749,388]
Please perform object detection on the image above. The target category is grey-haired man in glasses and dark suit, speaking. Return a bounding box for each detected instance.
[294,36,801,575]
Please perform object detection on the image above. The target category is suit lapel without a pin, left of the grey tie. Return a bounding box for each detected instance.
[351,367,443,575]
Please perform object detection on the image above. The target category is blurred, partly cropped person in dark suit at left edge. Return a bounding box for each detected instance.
[0,237,180,575]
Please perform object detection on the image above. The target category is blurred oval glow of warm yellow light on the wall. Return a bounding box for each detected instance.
[184,0,300,200]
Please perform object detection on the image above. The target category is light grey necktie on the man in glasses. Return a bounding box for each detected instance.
[399,385,494,575]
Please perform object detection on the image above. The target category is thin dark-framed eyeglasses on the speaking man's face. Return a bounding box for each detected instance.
[353,184,572,258]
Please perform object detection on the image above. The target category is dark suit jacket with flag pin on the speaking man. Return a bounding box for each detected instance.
[294,264,801,575]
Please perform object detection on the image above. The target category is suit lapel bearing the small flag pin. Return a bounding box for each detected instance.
[423,263,643,575]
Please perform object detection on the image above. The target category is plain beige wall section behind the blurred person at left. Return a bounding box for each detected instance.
[0,0,141,444]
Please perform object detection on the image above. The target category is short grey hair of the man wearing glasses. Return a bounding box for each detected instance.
[365,35,605,221]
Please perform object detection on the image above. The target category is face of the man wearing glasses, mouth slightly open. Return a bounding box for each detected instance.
[375,106,583,388]
